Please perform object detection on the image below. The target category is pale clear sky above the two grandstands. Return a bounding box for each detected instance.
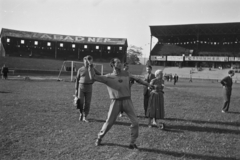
[0,0,240,57]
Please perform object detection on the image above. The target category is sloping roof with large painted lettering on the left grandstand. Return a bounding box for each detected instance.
[1,28,128,46]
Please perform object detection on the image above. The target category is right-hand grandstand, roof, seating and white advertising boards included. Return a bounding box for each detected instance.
[149,23,240,69]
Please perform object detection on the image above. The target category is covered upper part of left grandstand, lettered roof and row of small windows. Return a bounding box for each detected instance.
[0,28,128,62]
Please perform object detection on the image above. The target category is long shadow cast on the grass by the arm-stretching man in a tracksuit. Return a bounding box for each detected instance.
[102,143,236,160]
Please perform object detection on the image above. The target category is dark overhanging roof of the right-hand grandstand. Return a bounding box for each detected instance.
[150,22,240,41]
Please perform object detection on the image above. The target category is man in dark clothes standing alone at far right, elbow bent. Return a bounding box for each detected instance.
[220,70,234,113]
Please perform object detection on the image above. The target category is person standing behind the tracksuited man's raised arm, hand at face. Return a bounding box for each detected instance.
[75,56,100,122]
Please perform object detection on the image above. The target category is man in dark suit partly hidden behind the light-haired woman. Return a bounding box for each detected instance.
[143,65,155,117]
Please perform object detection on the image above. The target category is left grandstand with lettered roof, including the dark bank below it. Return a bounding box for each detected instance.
[0,28,147,79]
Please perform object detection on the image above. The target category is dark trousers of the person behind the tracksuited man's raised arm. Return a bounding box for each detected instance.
[77,90,92,117]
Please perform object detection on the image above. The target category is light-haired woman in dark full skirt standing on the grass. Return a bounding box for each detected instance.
[147,70,164,129]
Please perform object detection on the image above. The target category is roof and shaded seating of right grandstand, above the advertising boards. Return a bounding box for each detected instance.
[150,22,240,56]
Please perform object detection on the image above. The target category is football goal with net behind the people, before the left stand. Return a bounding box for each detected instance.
[57,61,103,81]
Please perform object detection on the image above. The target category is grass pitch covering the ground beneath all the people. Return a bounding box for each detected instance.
[0,79,240,160]
